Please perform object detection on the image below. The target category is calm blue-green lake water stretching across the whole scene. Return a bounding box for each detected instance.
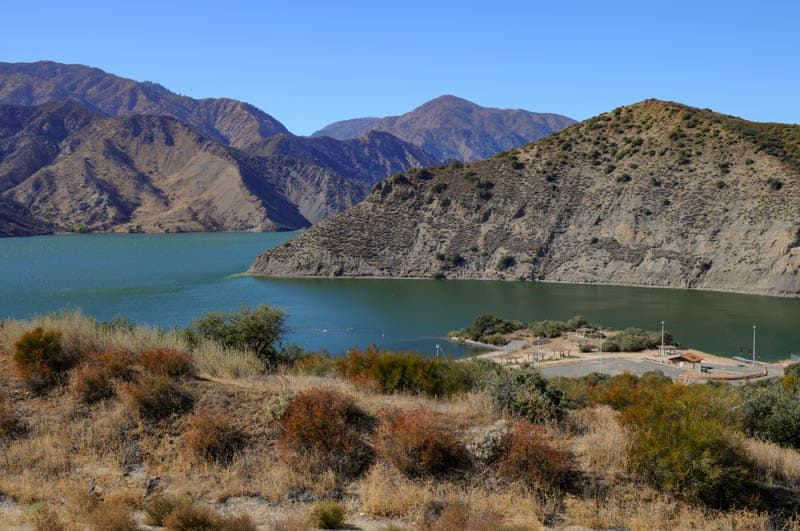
[0,233,800,360]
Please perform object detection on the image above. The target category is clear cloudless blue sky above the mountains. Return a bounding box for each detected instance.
[0,0,800,134]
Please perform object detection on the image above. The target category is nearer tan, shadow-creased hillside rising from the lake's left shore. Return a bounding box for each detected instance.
[0,101,310,235]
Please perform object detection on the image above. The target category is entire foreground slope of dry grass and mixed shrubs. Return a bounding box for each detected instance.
[0,307,800,530]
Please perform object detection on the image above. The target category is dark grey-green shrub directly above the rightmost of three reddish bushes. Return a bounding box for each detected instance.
[490,368,566,422]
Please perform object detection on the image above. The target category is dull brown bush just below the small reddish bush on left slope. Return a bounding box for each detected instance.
[124,376,194,421]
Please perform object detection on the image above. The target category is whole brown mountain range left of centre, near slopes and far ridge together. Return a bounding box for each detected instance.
[0,61,568,235]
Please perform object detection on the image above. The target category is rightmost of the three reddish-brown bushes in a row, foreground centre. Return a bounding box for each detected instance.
[498,420,572,488]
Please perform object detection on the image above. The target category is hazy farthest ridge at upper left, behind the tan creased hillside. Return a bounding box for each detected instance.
[0,61,288,149]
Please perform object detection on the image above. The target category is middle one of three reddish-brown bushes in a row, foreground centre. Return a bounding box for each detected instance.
[376,408,469,477]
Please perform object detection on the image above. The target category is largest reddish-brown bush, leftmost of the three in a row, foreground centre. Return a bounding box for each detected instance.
[279,389,375,477]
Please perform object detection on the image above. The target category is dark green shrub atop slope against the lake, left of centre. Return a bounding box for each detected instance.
[191,305,286,366]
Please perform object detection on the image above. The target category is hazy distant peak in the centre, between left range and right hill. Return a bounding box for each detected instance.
[312,96,575,162]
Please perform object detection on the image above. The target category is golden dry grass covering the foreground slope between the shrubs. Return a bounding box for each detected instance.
[0,313,800,530]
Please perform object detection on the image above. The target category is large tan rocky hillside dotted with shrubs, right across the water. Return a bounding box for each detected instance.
[250,100,800,296]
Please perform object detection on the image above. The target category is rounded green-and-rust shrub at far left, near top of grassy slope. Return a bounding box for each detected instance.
[13,327,78,392]
